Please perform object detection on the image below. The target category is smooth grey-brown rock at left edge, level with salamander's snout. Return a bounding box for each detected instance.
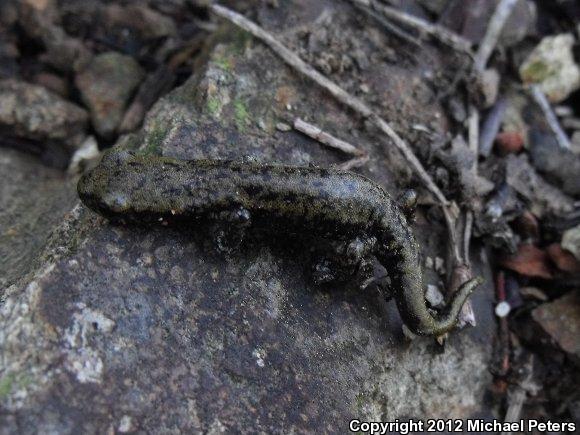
[0,148,77,292]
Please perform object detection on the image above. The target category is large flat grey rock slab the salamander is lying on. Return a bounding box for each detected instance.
[0,1,494,433]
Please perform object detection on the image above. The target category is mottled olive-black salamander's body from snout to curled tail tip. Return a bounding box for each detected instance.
[78,150,480,335]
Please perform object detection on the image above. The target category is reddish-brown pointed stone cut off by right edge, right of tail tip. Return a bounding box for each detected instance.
[532,290,580,360]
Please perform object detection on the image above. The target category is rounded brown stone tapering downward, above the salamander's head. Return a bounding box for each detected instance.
[75,52,144,138]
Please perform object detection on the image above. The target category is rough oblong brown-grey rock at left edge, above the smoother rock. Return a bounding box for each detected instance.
[0,79,88,162]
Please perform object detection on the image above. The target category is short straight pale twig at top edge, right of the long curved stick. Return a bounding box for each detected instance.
[352,0,473,56]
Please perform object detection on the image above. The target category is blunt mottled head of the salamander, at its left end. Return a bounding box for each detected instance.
[77,150,134,216]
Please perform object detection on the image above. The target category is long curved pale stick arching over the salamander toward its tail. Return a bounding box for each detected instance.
[210,4,461,284]
